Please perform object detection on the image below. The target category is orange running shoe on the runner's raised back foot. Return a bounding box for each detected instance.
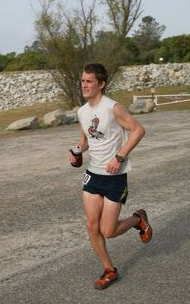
[133,209,152,243]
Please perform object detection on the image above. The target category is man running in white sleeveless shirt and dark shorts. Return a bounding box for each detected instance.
[69,63,152,289]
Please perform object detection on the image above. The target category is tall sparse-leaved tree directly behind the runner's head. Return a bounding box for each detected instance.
[36,0,142,106]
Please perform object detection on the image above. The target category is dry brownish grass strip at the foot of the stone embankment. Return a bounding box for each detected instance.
[0,86,190,135]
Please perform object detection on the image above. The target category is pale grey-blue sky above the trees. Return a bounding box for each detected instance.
[0,0,190,54]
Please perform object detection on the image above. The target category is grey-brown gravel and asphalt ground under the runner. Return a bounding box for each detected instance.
[0,112,190,304]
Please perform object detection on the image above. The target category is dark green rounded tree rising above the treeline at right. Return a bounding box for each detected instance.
[133,16,166,64]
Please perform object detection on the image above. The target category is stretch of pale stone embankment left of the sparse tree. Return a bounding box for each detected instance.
[0,71,62,111]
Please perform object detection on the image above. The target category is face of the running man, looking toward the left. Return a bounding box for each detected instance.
[81,72,105,100]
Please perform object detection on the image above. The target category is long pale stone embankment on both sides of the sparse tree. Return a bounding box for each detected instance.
[0,63,190,111]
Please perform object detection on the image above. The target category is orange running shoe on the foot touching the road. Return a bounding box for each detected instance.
[94,268,118,290]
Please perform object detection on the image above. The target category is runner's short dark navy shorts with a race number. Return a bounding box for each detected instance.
[83,170,128,204]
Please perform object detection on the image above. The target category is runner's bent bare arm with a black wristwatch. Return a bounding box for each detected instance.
[106,103,145,173]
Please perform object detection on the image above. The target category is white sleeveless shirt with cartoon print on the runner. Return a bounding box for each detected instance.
[78,95,131,175]
